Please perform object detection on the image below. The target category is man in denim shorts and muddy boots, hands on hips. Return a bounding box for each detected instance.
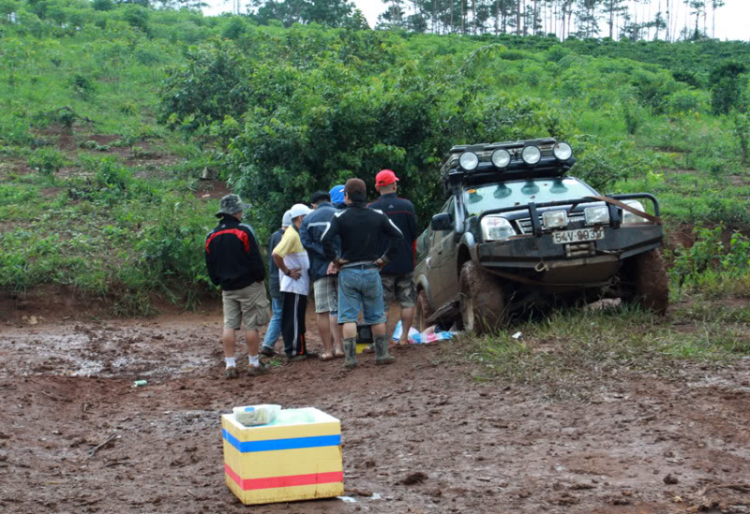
[321,178,403,368]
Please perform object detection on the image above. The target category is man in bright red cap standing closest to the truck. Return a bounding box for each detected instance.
[370,170,418,345]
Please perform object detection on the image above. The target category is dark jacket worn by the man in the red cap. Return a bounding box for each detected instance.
[370,193,418,275]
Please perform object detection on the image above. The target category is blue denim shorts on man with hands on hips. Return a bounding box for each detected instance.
[339,267,385,325]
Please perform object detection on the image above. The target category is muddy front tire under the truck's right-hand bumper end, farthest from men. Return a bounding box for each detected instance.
[627,248,669,316]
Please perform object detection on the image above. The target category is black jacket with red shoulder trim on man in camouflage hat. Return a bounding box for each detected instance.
[206,215,266,291]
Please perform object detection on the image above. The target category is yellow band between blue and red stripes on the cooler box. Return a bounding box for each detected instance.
[224,441,344,478]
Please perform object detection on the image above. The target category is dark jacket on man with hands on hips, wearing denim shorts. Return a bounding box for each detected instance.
[321,203,403,264]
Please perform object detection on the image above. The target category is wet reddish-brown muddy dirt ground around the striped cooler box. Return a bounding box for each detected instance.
[0,300,750,514]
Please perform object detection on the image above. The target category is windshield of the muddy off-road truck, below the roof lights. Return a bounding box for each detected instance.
[464,178,597,216]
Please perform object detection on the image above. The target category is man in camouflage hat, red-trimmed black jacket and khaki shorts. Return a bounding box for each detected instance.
[205,195,270,379]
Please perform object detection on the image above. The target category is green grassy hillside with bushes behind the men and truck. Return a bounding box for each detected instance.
[0,0,750,314]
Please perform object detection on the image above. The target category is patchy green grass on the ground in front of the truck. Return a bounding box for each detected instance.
[469,302,750,397]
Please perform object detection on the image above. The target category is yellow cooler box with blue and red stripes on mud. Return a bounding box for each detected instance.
[221,407,344,505]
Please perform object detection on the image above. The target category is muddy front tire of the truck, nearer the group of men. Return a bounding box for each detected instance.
[459,261,507,335]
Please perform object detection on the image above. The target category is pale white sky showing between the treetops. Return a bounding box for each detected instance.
[204,0,750,41]
